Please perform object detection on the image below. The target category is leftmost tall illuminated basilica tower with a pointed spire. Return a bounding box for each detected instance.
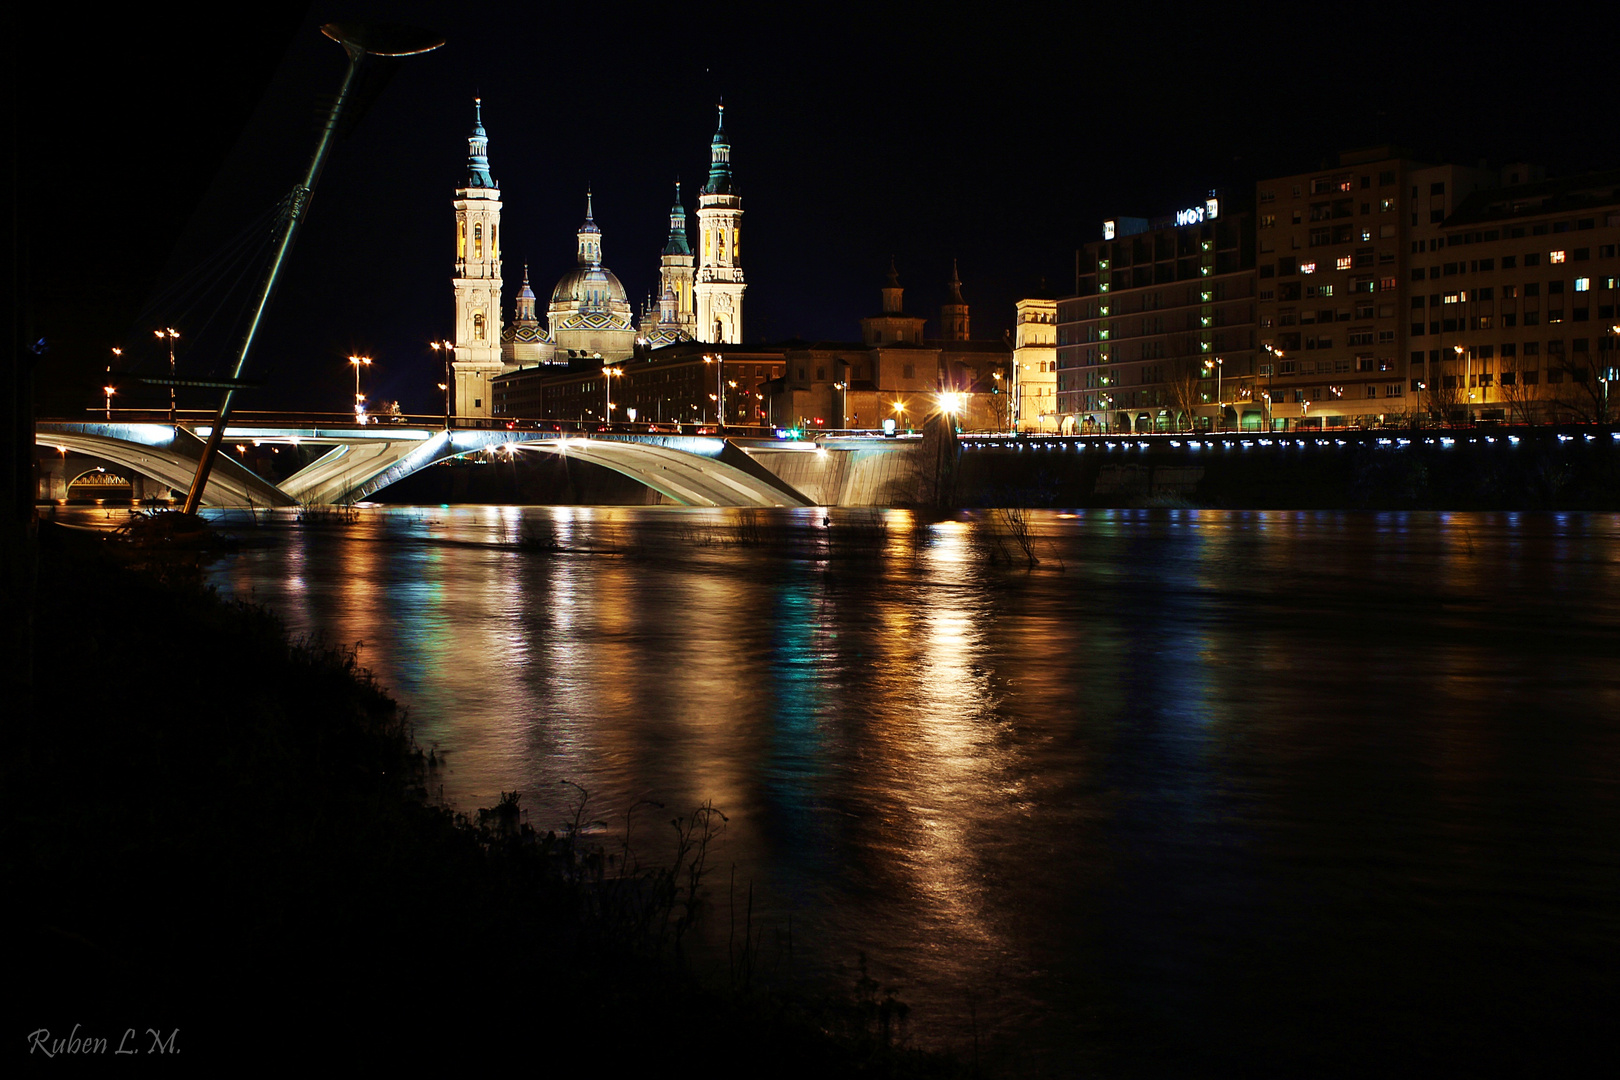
[455,97,502,418]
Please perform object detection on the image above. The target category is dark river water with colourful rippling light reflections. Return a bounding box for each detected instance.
[132,507,1620,1075]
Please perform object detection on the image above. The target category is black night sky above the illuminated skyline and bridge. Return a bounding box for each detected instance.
[25,3,1620,415]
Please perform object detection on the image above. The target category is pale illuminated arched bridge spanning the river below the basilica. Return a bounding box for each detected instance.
[34,421,816,507]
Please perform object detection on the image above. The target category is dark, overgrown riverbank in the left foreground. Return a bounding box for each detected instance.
[3,533,975,1077]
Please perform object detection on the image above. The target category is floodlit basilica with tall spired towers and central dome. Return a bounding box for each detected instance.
[452,100,747,419]
